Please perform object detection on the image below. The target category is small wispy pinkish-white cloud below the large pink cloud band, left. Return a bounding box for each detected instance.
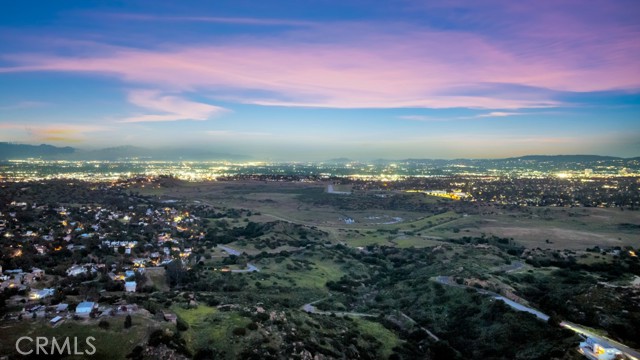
[120,90,228,123]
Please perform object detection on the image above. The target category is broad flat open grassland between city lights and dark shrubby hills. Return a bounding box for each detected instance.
[140,181,640,253]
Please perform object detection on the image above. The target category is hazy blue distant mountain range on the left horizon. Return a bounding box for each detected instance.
[0,142,250,161]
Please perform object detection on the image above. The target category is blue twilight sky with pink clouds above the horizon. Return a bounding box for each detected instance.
[0,0,640,160]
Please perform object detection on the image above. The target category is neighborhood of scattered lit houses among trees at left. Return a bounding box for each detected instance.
[0,191,209,332]
